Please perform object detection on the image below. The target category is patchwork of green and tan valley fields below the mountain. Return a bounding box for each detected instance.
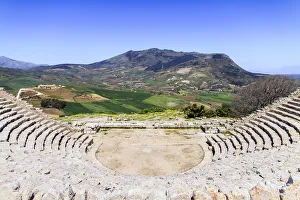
[14,83,232,117]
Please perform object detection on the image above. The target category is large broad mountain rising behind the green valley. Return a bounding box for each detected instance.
[30,48,263,92]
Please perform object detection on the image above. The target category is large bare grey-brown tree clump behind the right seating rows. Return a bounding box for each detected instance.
[232,75,297,116]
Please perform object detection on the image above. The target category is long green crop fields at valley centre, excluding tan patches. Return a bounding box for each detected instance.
[64,88,188,115]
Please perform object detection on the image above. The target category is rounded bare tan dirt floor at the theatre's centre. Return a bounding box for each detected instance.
[96,129,204,176]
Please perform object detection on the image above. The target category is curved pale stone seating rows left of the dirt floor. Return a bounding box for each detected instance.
[0,91,93,156]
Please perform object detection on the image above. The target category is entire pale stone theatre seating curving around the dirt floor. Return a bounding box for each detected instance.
[0,90,300,200]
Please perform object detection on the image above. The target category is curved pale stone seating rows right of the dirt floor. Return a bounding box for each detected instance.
[206,97,300,160]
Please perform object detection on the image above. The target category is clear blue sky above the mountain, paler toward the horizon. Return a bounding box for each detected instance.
[0,0,300,73]
